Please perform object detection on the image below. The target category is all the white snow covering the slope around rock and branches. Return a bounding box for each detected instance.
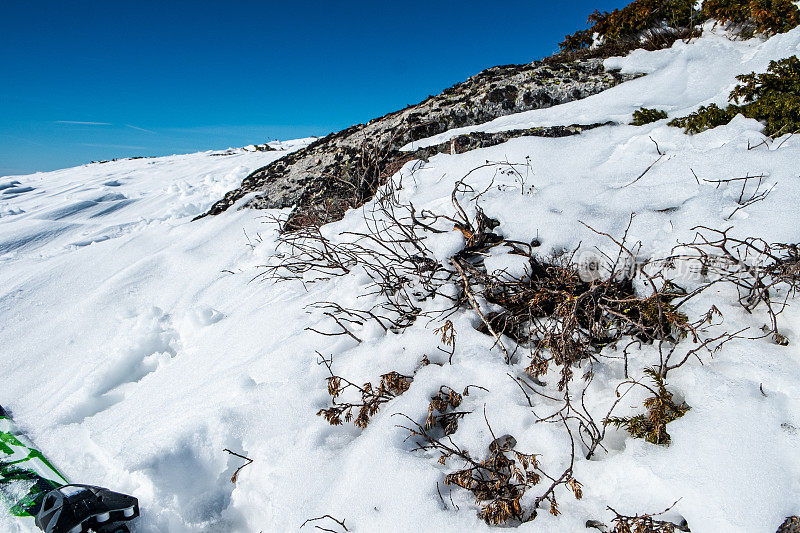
[0,29,800,533]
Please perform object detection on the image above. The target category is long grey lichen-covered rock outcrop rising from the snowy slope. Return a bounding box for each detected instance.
[203,59,632,225]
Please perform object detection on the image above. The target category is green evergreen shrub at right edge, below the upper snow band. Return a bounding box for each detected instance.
[668,56,800,137]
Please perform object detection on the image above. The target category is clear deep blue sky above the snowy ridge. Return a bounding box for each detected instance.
[0,0,628,175]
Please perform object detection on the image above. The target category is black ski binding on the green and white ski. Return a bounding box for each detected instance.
[36,485,139,533]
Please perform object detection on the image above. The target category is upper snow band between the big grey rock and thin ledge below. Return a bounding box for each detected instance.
[404,23,800,150]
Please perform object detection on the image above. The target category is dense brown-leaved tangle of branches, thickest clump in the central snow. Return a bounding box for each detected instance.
[454,216,724,390]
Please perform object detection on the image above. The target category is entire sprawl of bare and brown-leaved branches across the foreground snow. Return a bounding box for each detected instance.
[262,156,780,531]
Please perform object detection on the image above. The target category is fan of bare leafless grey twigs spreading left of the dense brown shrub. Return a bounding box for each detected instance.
[257,179,452,330]
